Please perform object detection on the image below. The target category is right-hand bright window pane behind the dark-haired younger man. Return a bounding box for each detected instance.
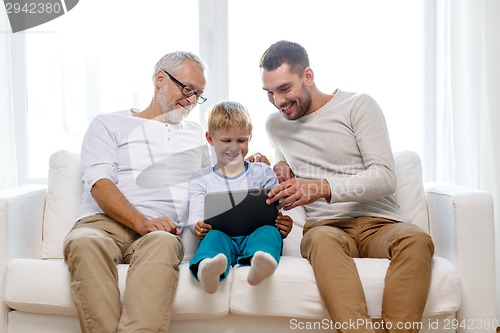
[228,0,424,163]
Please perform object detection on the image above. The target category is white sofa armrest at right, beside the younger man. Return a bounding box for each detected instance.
[425,183,496,332]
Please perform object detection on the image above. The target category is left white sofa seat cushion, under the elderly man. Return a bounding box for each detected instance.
[4,259,232,320]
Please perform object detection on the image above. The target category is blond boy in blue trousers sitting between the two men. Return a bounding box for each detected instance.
[188,101,292,294]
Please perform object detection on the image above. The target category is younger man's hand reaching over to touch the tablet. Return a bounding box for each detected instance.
[266,178,331,210]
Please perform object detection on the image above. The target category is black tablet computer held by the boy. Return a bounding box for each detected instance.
[204,188,278,237]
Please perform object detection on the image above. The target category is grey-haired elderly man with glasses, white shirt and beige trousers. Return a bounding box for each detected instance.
[64,52,210,332]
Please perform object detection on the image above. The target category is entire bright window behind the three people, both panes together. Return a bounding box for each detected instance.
[20,0,424,183]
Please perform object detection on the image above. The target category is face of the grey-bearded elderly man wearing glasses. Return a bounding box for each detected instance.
[156,60,206,124]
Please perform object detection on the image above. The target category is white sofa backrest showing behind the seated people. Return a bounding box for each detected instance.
[42,151,429,259]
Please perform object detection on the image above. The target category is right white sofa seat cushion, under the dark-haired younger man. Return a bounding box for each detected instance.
[230,257,461,319]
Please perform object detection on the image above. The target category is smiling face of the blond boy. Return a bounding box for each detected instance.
[206,127,251,171]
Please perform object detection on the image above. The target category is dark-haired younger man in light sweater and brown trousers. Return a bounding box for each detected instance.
[260,41,434,332]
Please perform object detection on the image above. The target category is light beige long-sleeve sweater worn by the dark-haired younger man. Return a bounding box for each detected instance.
[266,91,404,221]
